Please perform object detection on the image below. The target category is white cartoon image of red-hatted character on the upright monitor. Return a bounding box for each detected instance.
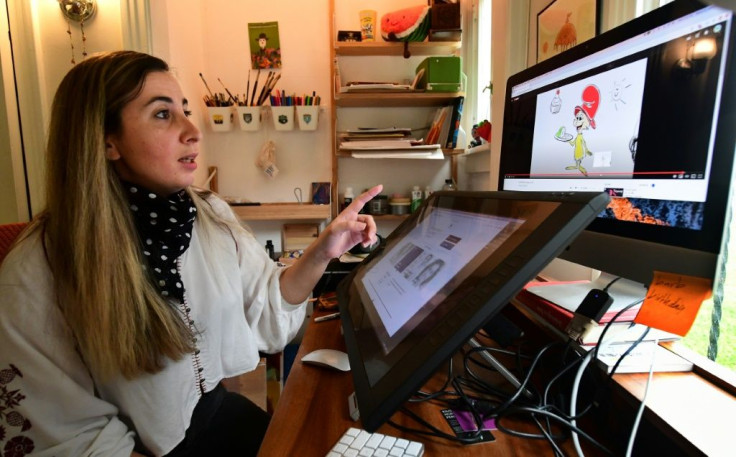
[531,59,647,178]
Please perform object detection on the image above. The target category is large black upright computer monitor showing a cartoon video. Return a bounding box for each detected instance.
[499,0,736,284]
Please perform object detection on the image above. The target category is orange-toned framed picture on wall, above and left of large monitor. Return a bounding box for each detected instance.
[537,0,599,62]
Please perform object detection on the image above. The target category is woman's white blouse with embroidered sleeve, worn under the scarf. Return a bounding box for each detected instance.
[0,197,305,457]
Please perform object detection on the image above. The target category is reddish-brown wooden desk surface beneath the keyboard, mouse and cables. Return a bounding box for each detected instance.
[259,314,595,457]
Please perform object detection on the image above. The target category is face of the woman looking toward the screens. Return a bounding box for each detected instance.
[105,71,201,196]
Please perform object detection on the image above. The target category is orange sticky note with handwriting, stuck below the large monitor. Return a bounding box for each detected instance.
[634,271,712,336]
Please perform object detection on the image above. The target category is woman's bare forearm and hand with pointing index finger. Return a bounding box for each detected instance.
[281,185,383,303]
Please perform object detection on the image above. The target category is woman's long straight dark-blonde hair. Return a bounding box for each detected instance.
[28,51,233,379]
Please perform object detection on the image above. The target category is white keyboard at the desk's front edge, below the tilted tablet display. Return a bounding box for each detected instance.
[326,427,424,457]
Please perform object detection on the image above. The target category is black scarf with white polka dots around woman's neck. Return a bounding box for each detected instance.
[123,182,197,302]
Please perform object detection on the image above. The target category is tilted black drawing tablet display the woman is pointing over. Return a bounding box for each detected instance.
[338,191,609,432]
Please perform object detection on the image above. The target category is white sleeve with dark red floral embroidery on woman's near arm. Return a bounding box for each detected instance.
[0,239,134,457]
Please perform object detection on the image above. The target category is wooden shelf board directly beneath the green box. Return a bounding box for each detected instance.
[335,92,465,108]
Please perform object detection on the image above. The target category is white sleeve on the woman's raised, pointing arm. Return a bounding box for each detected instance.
[211,194,306,353]
